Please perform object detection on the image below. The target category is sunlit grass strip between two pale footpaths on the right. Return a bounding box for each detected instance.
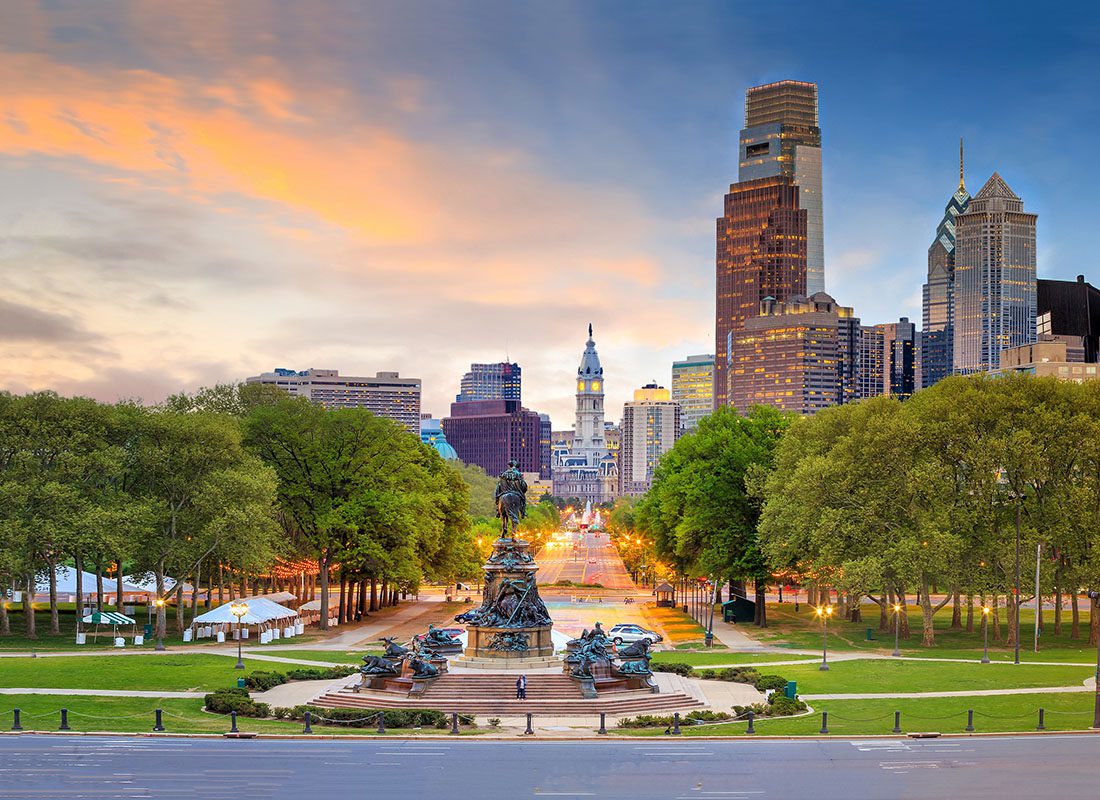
[769,659,1093,694]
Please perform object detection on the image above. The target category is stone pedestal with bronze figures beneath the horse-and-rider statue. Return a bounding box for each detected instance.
[455,539,553,667]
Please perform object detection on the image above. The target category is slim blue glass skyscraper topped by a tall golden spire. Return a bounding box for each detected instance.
[921,139,970,387]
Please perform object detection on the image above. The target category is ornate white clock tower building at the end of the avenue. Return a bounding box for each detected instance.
[552,325,618,504]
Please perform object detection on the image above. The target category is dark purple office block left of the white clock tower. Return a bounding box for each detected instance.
[443,399,542,475]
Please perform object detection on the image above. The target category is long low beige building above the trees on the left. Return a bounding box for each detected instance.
[244,369,420,436]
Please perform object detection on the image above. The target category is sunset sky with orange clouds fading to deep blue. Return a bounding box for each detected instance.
[0,0,1100,428]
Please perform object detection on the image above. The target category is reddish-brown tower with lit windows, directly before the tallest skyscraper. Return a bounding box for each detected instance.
[714,175,806,407]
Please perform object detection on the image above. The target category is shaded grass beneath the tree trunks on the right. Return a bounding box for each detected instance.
[739,603,1097,665]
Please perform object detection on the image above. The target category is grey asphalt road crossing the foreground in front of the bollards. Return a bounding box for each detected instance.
[0,735,1100,800]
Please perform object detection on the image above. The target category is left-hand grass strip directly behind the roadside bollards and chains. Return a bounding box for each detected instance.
[0,694,477,735]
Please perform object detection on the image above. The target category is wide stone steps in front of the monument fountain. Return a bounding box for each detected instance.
[312,673,703,717]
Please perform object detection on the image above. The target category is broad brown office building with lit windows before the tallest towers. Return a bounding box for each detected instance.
[729,292,859,414]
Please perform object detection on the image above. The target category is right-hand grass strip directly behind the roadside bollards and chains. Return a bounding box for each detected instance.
[615,693,1093,736]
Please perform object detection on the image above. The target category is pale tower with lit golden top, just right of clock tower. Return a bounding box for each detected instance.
[619,383,681,495]
